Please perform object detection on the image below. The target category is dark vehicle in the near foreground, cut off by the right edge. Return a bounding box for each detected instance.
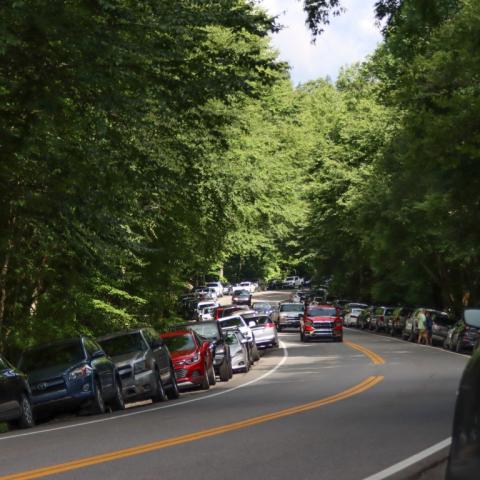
[445,344,480,480]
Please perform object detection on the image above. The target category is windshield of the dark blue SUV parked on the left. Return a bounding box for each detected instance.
[18,340,85,373]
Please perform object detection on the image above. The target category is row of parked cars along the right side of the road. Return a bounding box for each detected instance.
[342,303,480,352]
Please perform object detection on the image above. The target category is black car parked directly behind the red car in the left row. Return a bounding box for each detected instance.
[177,320,232,382]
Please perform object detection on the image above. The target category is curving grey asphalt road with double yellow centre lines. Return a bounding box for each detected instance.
[0,294,467,480]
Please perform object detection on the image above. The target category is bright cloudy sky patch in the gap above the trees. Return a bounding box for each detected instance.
[260,0,382,85]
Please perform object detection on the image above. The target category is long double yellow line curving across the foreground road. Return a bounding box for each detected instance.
[0,376,384,480]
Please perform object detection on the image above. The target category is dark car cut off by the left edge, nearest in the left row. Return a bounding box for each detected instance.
[0,355,35,428]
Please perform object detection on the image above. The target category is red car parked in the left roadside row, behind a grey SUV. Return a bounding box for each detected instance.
[161,330,216,390]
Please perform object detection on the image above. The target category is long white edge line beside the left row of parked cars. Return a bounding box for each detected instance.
[0,341,288,441]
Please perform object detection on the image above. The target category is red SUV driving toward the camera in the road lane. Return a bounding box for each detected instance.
[300,305,343,342]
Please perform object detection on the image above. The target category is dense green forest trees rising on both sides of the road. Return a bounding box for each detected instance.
[0,0,480,352]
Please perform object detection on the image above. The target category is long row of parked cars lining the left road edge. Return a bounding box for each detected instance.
[0,292,278,428]
